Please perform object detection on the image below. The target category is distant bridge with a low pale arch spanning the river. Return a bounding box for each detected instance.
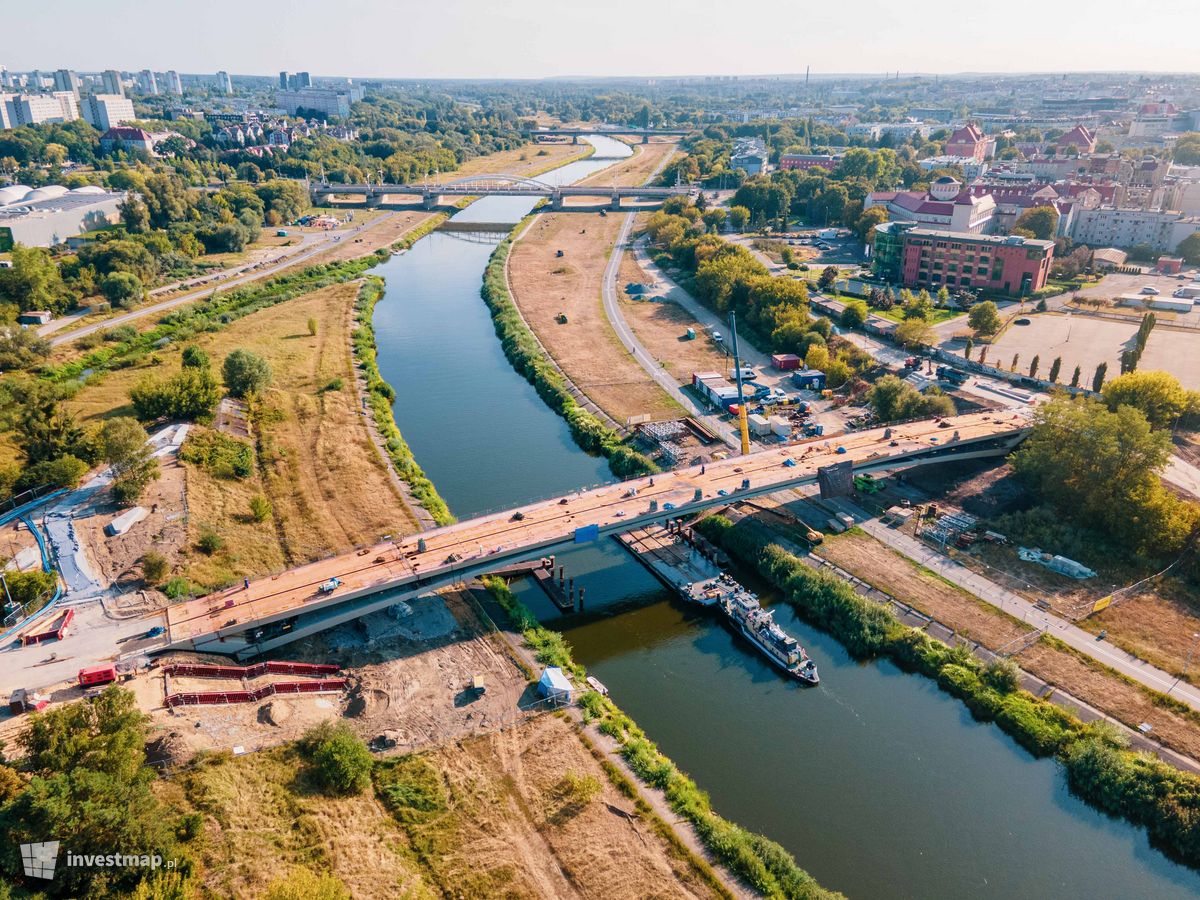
[310,173,695,210]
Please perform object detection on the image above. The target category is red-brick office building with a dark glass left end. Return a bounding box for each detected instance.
[874,222,1054,296]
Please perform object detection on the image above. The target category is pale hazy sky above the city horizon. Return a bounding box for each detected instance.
[9,0,1200,78]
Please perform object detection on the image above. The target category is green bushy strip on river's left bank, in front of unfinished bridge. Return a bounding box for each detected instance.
[486,578,840,899]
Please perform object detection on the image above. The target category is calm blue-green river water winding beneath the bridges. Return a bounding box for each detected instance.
[374,137,1200,900]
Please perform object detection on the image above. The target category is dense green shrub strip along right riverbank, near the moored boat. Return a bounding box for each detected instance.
[697,516,1200,868]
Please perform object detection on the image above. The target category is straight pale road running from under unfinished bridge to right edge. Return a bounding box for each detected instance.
[838,503,1200,710]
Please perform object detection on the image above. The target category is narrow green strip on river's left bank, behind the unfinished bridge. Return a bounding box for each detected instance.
[353,275,455,524]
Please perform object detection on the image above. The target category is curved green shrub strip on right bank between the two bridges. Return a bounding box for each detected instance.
[480,220,659,478]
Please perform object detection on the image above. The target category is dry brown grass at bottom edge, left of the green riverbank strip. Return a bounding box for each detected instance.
[396,716,712,899]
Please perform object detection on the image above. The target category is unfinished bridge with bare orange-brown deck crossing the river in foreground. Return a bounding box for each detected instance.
[157,410,1030,659]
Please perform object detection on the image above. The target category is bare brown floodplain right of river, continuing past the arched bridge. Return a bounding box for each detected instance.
[509,144,680,422]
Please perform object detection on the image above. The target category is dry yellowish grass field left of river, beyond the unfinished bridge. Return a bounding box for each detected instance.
[71,282,416,586]
